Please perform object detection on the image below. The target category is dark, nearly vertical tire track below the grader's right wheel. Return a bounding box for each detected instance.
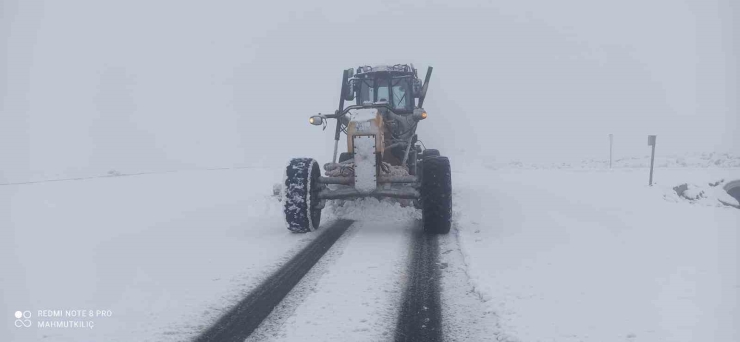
[395,229,442,342]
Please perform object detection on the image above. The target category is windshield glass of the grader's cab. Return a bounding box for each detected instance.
[357,77,414,112]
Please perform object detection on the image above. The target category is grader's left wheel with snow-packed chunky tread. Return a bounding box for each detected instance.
[283,158,321,233]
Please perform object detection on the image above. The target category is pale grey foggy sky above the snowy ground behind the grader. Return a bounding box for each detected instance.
[0,0,740,182]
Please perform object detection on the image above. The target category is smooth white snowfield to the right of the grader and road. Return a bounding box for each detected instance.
[453,167,740,342]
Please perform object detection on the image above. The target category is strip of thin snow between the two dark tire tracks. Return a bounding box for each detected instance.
[247,218,418,342]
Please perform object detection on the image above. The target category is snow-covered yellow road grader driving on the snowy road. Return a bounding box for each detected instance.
[282,64,452,234]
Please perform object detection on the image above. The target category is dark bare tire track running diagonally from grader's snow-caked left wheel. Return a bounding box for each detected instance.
[195,220,353,342]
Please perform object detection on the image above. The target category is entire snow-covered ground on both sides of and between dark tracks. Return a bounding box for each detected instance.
[0,158,740,342]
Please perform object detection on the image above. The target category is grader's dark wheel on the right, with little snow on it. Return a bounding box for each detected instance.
[421,156,452,234]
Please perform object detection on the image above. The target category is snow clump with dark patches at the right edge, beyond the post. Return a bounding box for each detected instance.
[663,179,740,208]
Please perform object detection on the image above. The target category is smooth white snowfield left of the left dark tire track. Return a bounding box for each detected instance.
[0,169,304,341]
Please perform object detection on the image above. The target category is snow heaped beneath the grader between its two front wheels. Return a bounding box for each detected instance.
[325,198,421,222]
